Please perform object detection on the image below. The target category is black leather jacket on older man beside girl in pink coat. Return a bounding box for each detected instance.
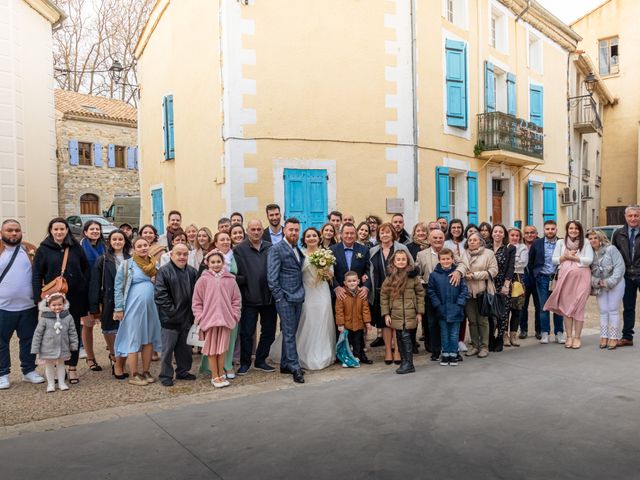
[154,261,198,330]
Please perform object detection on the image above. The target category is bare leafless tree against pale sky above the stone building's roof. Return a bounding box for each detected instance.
[53,0,155,105]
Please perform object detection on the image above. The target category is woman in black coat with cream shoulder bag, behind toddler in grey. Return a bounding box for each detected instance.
[33,217,90,384]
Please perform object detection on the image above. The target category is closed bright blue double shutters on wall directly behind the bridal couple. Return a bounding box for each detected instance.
[284,168,328,235]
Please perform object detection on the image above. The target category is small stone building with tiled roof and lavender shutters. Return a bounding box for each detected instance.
[55,90,140,217]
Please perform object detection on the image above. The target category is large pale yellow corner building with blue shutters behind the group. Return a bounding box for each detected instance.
[135,0,580,229]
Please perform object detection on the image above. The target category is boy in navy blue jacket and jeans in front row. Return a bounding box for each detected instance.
[427,248,469,366]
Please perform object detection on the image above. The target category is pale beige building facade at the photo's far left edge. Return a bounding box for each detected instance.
[0,0,64,242]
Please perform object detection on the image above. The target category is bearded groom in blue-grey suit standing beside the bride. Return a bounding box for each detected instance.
[267,218,304,383]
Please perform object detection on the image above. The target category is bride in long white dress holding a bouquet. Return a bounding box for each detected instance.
[269,228,336,370]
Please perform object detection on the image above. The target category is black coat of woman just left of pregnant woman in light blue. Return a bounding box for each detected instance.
[89,252,129,330]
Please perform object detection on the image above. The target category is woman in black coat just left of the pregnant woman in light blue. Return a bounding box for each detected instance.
[89,230,131,380]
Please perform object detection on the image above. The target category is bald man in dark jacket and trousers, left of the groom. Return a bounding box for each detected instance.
[233,220,280,375]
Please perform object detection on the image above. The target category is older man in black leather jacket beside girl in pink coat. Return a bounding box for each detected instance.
[155,243,198,387]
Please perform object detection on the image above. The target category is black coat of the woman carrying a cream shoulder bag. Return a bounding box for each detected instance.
[32,236,91,322]
